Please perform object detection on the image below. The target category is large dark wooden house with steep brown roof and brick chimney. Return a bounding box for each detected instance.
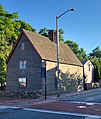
[6,30,83,94]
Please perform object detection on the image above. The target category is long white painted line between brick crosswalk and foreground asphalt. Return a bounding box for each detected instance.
[23,108,101,119]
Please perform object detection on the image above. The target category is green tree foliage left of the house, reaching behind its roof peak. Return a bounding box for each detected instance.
[0,5,35,87]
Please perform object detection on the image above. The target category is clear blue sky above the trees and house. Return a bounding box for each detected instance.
[0,0,101,53]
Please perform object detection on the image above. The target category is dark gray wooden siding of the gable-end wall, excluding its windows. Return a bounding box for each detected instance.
[7,35,42,91]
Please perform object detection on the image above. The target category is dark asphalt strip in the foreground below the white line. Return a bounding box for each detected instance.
[0,109,98,119]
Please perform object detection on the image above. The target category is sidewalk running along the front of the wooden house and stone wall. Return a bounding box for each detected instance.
[0,88,101,106]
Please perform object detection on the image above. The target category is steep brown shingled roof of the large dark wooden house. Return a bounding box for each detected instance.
[7,30,83,66]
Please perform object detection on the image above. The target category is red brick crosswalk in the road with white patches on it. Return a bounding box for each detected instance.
[27,101,101,115]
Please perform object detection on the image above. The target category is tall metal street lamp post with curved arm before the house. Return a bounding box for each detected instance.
[56,8,74,97]
